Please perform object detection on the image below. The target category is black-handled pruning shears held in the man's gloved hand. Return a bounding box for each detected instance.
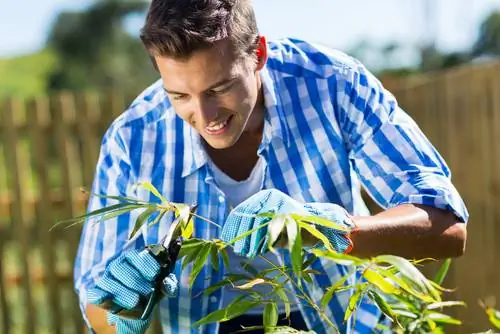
[116,204,198,320]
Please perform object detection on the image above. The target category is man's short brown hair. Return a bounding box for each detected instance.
[140,0,259,58]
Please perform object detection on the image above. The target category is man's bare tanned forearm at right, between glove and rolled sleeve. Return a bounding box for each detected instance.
[351,204,467,259]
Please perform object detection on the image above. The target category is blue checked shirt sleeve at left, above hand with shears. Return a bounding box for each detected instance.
[74,122,144,330]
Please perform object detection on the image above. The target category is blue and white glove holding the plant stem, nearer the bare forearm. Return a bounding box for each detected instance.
[221,189,354,257]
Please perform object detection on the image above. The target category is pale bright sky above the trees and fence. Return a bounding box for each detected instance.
[0,0,500,67]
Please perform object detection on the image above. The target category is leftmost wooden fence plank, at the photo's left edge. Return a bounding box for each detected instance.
[1,99,35,333]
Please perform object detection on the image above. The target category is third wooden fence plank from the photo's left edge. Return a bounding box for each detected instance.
[53,93,83,333]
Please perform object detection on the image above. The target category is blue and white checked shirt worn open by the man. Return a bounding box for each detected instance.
[74,39,468,333]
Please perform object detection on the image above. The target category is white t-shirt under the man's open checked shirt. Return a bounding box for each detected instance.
[208,157,298,314]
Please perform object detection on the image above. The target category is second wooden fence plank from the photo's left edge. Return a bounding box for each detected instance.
[29,98,62,333]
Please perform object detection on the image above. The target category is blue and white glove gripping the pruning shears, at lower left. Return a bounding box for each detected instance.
[87,250,179,334]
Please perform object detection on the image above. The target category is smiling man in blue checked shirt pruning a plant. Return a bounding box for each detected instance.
[75,0,468,333]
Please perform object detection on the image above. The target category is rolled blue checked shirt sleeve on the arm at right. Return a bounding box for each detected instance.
[335,60,469,222]
